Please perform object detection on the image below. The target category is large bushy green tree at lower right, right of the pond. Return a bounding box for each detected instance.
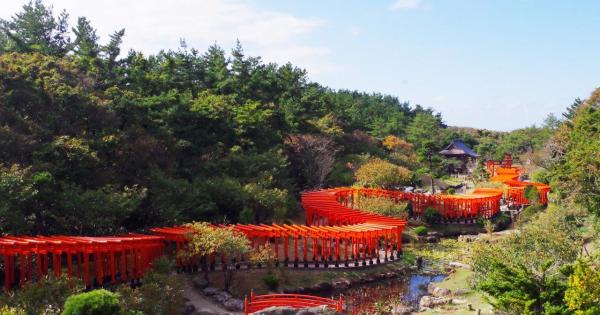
[471,207,581,314]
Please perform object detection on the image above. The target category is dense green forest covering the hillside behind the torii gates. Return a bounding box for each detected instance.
[0,1,572,238]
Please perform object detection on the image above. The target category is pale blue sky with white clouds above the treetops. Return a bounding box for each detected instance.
[0,0,600,130]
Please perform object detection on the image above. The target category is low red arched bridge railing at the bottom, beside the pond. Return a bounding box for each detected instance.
[244,293,344,315]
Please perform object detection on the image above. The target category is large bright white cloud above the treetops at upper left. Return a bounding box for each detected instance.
[0,0,344,73]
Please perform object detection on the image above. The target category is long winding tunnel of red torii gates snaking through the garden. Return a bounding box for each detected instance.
[0,160,550,291]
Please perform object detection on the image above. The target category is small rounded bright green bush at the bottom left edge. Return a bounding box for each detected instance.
[62,289,121,315]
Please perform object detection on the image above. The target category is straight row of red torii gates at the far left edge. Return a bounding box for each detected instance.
[0,234,164,291]
